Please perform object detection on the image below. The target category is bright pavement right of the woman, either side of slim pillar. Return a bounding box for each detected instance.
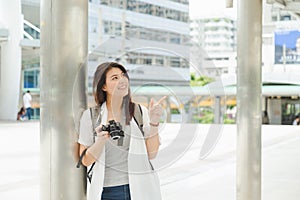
[160,125,300,200]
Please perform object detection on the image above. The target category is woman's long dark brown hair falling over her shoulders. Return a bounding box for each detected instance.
[93,62,134,125]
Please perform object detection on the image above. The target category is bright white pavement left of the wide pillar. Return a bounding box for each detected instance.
[0,121,40,200]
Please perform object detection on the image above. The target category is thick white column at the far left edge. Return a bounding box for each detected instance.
[0,0,23,120]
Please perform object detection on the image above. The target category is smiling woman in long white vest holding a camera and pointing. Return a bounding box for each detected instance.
[78,62,165,200]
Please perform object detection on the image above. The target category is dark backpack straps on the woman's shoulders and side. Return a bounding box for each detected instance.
[76,104,144,183]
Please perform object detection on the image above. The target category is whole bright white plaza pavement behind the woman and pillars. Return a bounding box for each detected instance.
[0,121,300,200]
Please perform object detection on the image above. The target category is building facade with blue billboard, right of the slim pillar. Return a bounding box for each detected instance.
[262,4,300,125]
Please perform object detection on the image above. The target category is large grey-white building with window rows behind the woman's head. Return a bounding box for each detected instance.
[89,0,190,85]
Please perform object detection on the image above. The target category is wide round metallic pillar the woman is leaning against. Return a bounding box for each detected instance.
[40,0,88,200]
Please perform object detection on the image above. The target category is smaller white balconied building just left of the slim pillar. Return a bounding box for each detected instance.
[190,16,236,76]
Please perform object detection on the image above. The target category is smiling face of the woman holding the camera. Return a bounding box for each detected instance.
[102,67,129,98]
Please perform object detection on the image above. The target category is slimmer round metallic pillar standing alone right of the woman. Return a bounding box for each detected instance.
[237,0,262,200]
